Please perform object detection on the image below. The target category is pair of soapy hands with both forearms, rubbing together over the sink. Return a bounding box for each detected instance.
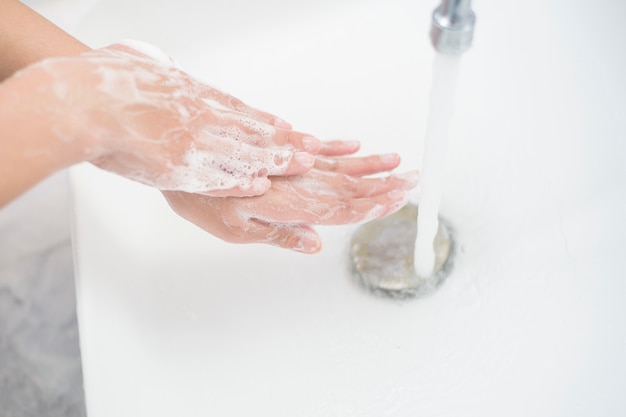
[0,0,417,253]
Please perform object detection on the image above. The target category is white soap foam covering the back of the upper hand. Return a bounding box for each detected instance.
[87,40,293,194]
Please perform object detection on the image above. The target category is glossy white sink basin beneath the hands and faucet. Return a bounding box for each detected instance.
[71,0,626,417]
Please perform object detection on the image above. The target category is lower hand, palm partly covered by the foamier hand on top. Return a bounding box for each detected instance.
[163,142,418,253]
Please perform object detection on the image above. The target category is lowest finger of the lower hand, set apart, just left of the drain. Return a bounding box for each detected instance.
[246,219,322,254]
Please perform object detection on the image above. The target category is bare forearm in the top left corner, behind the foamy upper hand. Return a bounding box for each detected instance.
[0,0,89,81]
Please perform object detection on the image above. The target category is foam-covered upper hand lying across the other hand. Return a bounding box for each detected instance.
[16,43,321,197]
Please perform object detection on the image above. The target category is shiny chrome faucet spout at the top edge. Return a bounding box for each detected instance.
[430,0,476,55]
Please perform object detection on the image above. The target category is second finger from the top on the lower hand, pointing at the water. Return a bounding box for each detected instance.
[315,154,400,177]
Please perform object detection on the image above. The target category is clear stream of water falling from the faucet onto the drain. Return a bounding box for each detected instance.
[413,53,461,278]
